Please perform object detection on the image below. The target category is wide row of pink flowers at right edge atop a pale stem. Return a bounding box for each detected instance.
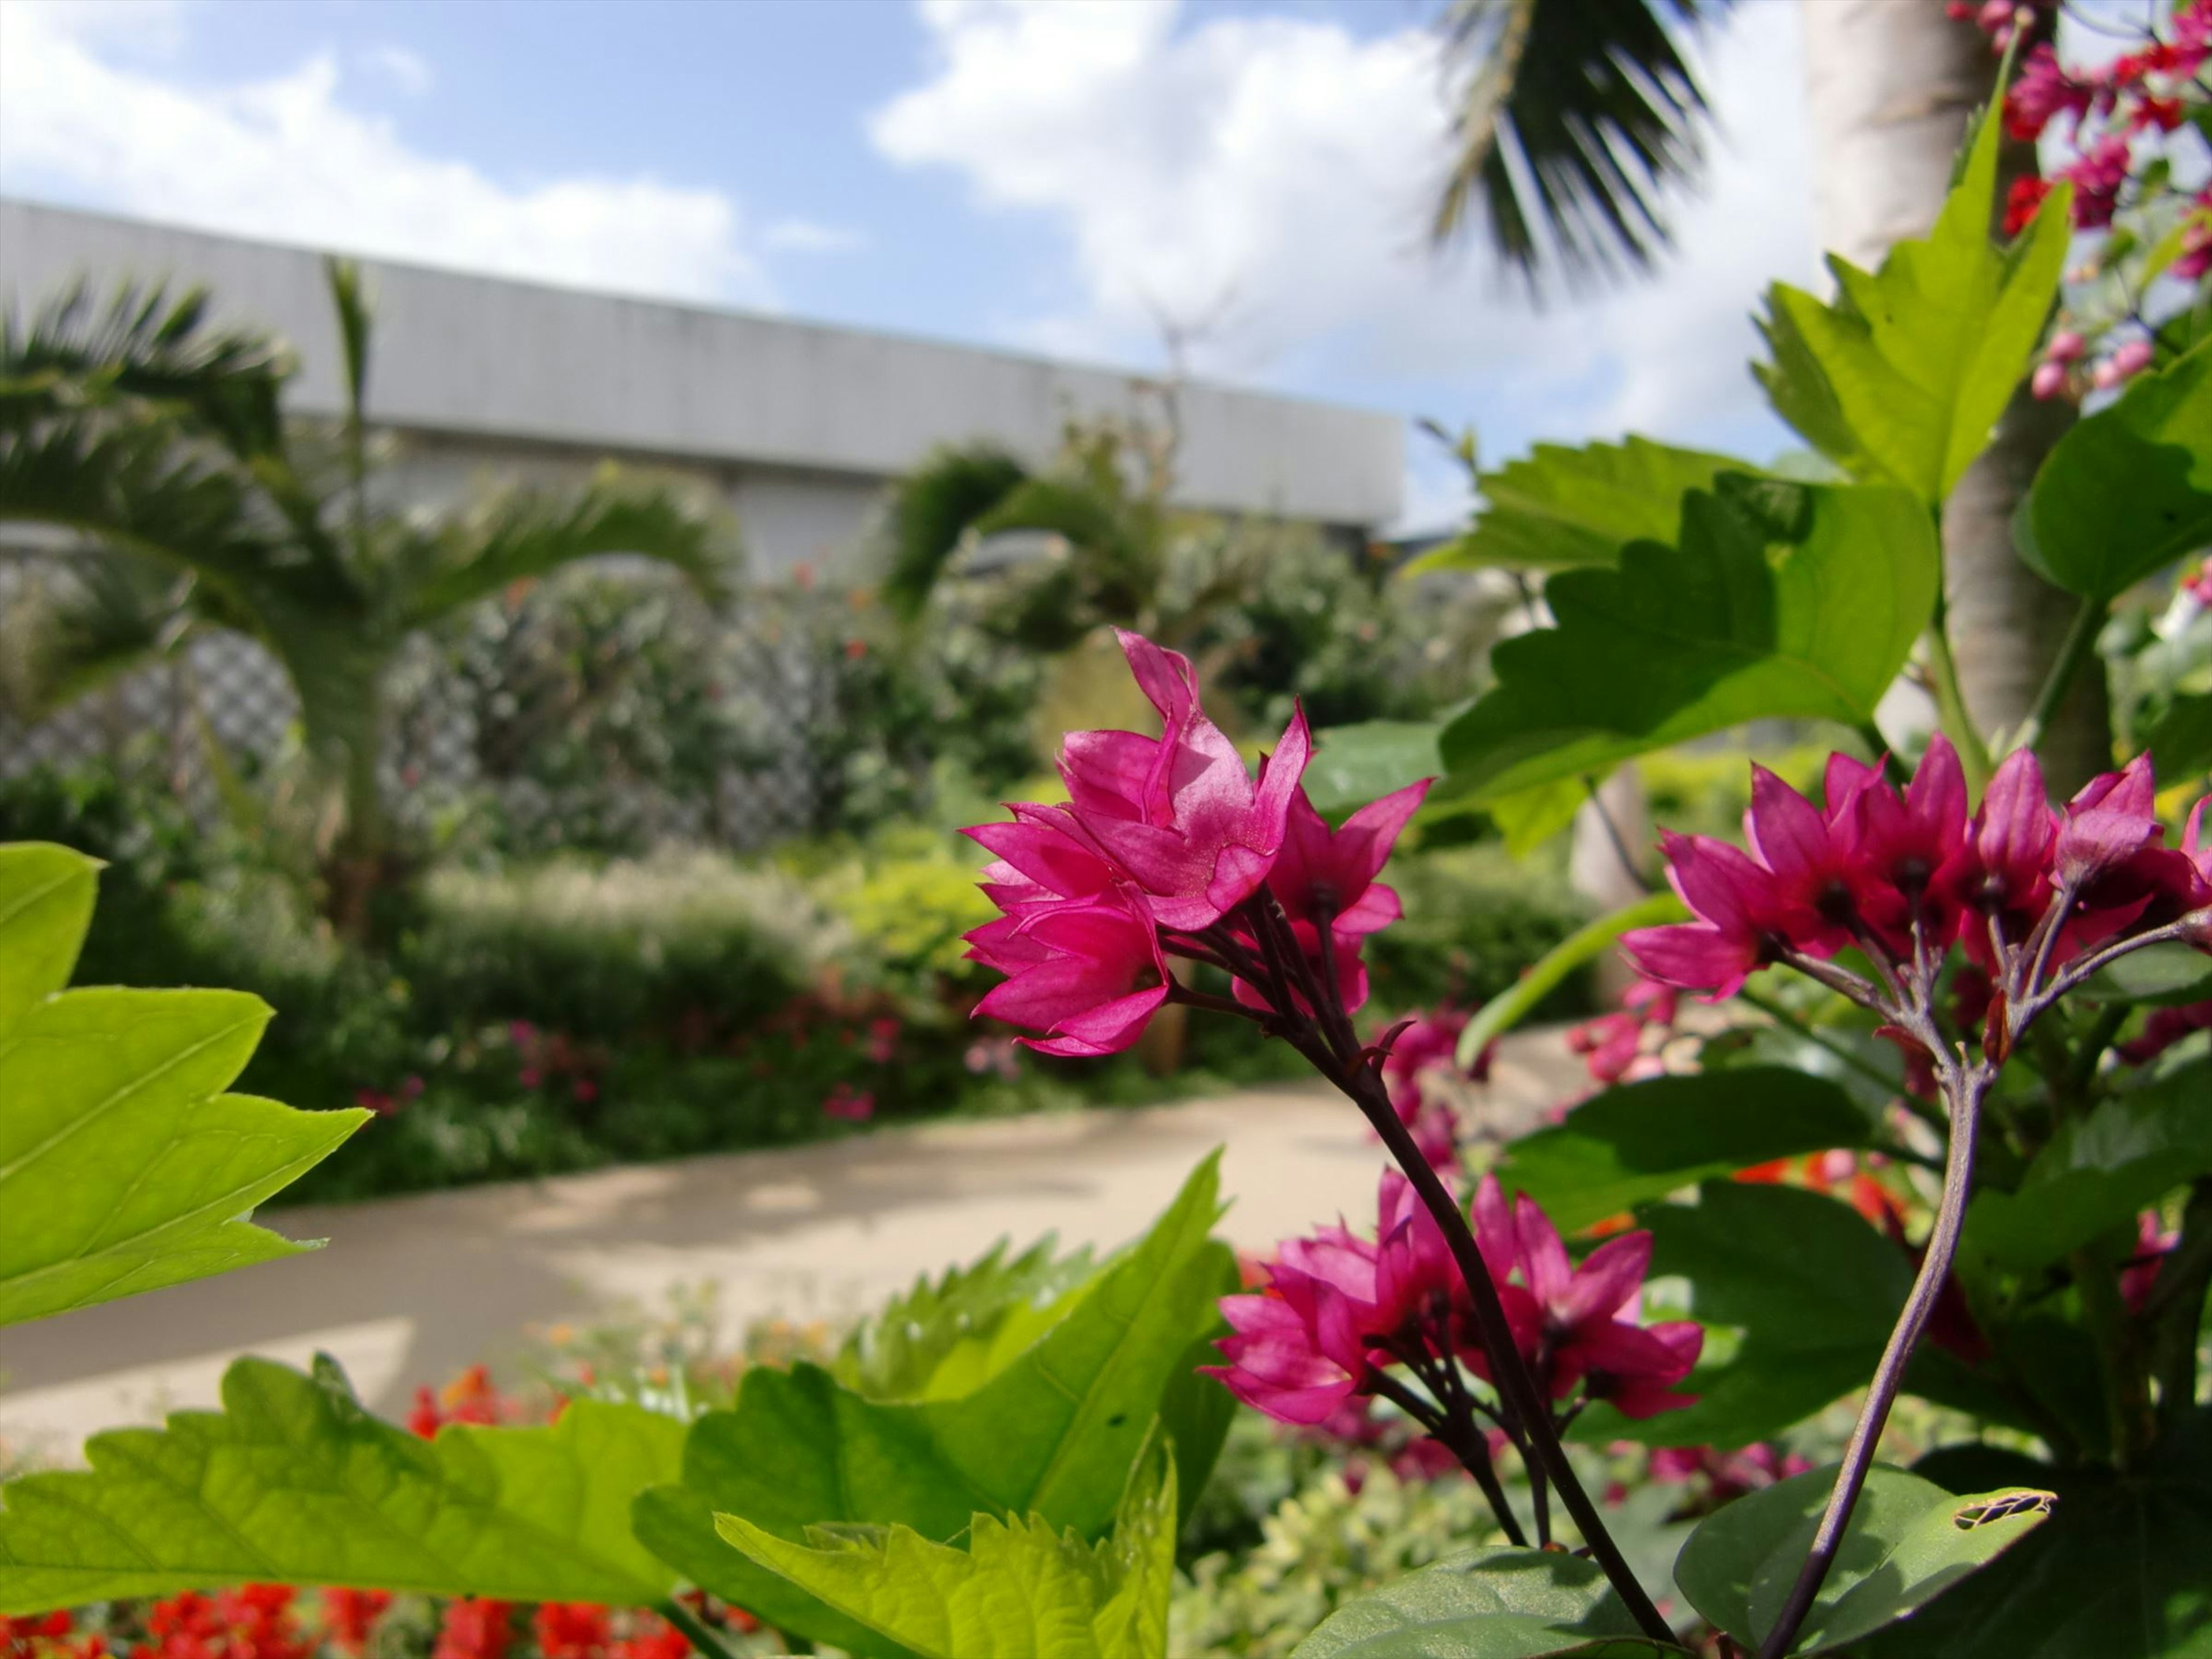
[1622,737,2212,998]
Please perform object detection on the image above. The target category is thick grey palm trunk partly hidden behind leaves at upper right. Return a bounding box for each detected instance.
[1801,0,2110,790]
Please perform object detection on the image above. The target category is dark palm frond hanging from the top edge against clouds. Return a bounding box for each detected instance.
[1431,0,1734,287]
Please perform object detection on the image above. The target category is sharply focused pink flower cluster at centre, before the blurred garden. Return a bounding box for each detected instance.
[967,632,1427,1055]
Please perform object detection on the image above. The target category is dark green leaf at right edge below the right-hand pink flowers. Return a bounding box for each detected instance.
[1960,1059,2212,1272]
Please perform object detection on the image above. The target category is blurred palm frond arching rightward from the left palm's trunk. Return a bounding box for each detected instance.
[389,480,741,628]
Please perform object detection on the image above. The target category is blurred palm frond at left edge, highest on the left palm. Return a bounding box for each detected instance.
[0,283,292,460]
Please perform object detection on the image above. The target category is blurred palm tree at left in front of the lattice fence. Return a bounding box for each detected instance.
[0,259,734,938]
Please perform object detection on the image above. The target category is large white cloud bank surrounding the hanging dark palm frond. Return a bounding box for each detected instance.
[869,0,1814,528]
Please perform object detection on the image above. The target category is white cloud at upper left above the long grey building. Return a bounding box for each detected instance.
[0,0,772,303]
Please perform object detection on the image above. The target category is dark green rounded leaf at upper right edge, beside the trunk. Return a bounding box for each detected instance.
[2015,343,2212,601]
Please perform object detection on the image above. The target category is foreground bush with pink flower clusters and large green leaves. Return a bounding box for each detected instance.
[0,48,2212,1659]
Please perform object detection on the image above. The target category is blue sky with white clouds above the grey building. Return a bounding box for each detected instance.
[0,0,1814,520]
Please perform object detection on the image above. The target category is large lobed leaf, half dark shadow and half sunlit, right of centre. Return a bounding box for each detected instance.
[1442,474,1938,803]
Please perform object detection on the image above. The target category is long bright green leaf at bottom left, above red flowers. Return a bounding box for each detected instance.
[0,1356,684,1612]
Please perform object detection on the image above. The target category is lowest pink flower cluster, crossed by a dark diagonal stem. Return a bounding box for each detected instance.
[1208,1170,1703,1431]
